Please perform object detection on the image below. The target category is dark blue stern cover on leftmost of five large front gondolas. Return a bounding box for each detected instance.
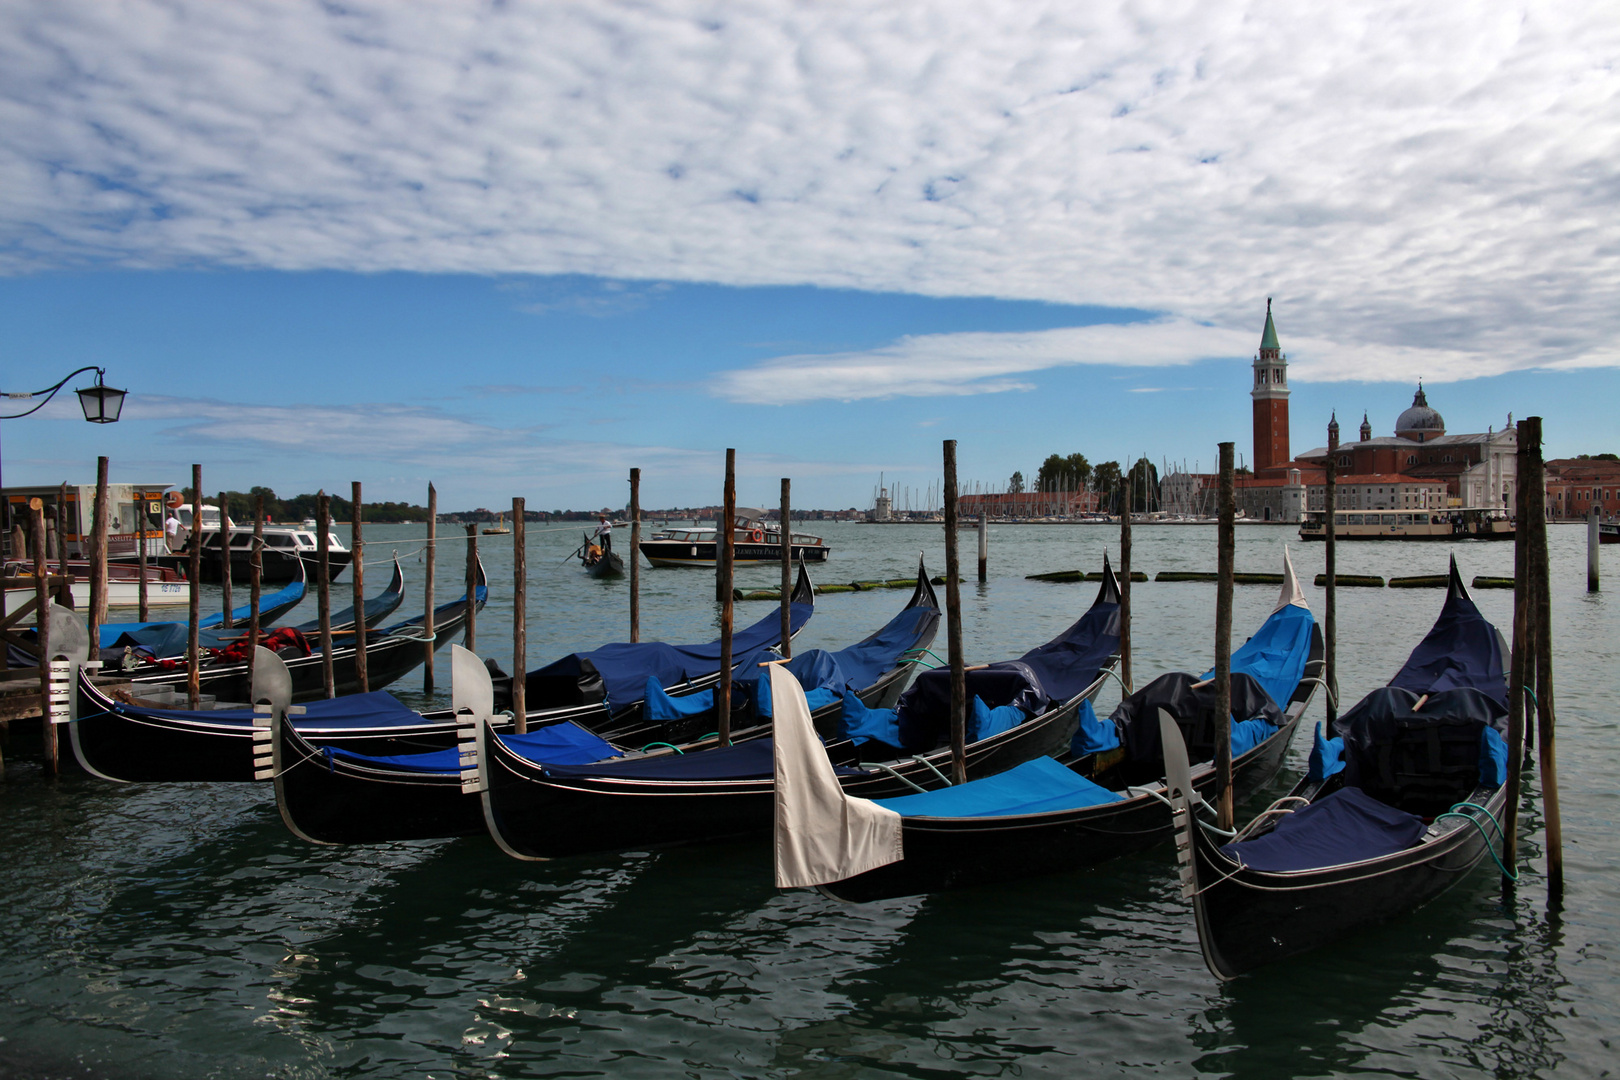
[528,604,815,709]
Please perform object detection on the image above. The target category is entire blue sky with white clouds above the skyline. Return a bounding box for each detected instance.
[0,0,1620,508]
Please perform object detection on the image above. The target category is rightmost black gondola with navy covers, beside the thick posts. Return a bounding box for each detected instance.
[1166,559,1508,980]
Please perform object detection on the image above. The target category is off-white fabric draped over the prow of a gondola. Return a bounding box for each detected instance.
[770,664,904,889]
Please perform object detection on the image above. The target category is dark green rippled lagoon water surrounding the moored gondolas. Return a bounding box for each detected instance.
[0,525,1620,1080]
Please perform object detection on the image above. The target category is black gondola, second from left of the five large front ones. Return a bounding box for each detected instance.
[272,573,940,844]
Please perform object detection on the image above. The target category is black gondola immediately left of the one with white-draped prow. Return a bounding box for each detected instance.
[478,562,1119,858]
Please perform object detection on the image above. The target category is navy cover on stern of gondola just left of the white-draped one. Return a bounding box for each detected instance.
[897,583,1119,750]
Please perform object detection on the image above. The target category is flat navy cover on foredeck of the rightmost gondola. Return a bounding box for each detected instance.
[1221,787,1426,873]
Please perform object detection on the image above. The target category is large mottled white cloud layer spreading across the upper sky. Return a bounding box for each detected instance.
[0,0,1620,369]
